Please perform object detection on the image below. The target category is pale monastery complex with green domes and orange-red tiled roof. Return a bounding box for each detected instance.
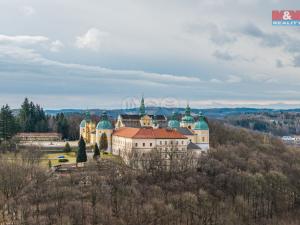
[80,98,209,158]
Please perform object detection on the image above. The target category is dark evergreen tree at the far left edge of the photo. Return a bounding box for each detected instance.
[0,105,17,141]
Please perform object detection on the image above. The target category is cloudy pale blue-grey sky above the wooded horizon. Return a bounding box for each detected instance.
[0,0,300,109]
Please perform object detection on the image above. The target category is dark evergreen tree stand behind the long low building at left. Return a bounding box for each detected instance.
[0,98,82,146]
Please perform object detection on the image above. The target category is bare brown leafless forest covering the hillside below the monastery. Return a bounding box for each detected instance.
[0,120,300,225]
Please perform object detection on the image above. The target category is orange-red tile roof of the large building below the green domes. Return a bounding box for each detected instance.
[113,127,187,139]
